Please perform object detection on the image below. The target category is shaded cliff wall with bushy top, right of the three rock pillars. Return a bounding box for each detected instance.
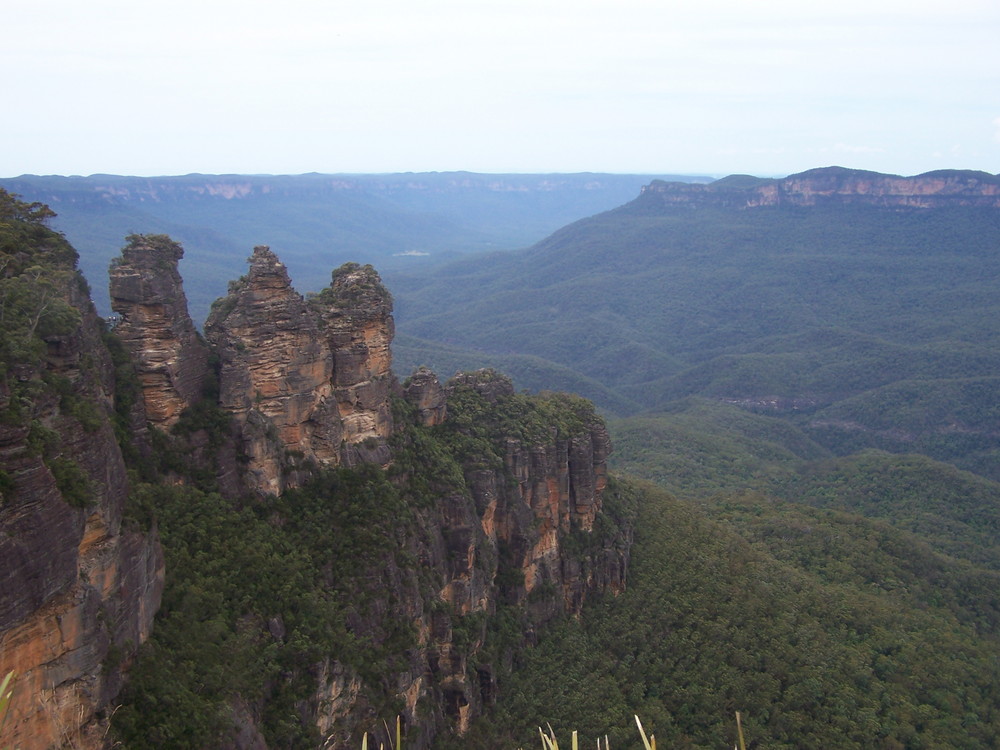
[316,369,632,749]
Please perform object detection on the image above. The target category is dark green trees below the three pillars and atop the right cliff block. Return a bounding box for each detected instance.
[113,373,624,748]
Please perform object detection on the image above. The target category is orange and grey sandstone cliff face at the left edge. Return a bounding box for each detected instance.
[0,229,164,748]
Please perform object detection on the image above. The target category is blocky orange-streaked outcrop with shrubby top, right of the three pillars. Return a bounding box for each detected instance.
[378,370,631,733]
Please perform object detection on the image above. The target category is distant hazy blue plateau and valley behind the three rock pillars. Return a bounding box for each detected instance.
[0,172,710,325]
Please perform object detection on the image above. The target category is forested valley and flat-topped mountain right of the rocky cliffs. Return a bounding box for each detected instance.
[394,170,1000,748]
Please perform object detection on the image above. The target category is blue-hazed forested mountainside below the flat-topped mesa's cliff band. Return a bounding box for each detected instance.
[393,170,1000,478]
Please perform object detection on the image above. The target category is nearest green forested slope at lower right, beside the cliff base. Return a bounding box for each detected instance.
[484,487,1000,748]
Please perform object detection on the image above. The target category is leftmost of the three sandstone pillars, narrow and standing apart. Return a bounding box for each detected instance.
[110,235,208,428]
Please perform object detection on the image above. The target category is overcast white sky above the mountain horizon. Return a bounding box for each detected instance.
[0,0,1000,177]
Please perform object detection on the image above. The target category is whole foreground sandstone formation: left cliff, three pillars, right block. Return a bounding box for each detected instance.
[0,201,630,750]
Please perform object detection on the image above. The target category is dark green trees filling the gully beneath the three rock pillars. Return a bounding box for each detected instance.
[114,468,415,748]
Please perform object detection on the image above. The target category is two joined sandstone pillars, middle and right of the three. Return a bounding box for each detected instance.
[205,246,394,493]
